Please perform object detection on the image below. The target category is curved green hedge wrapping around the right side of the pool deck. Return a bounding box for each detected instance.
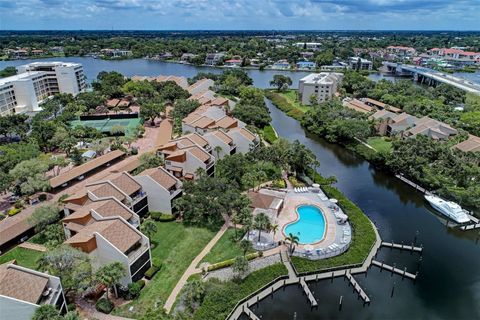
[292,178,376,273]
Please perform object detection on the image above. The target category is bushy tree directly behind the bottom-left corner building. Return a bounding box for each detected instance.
[38,245,92,295]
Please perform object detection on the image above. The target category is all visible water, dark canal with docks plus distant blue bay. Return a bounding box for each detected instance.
[0,57,480,320]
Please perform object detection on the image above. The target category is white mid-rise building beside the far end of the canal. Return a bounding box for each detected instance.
[298,72,343,105]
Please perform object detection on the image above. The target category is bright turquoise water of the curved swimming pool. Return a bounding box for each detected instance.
[284,205,325,244]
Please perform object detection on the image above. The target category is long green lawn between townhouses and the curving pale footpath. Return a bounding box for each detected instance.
[114,222,215,317]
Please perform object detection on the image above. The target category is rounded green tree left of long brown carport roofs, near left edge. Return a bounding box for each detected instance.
[9,158,50,195]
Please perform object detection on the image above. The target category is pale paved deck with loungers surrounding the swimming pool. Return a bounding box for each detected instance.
[274,190,351,251]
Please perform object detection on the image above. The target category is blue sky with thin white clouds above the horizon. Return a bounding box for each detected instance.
[0,0,480,31]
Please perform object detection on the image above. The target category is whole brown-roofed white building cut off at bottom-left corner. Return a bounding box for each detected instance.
[0,260,67,320]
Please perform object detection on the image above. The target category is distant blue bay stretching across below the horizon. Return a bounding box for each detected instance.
[0,57,480,88]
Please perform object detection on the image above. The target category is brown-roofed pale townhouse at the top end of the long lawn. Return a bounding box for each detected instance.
[135,167,182,213]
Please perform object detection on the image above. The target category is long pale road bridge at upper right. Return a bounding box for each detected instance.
[383,62,480,95]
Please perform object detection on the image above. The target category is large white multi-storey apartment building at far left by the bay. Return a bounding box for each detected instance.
[0,62,87,116]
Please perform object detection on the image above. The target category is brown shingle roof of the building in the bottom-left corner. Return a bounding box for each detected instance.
[0,263,48,304]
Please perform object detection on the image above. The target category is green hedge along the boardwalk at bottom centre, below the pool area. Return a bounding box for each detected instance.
[192,263,288,320]
